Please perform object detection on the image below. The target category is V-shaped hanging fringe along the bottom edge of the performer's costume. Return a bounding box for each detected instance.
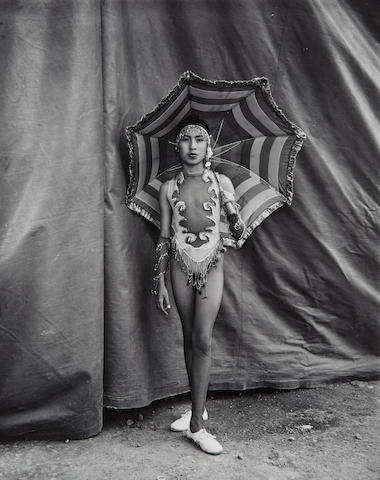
[172,238,226,292]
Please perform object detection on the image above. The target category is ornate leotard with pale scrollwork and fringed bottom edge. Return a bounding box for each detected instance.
[167,169,225,291]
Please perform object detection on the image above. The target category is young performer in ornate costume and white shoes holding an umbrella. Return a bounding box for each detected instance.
[154,117,245,454]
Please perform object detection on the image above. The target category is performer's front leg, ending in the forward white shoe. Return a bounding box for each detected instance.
[190,257,223,432]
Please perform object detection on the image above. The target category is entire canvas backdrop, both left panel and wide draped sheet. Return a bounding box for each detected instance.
[0,0,380,438]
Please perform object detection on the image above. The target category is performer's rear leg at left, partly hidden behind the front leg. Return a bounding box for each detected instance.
[170,259,197,389]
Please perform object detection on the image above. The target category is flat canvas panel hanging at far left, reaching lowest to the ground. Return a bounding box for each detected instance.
[0,0,103,438]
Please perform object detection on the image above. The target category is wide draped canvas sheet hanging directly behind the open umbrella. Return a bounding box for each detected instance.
[103,0,379,408]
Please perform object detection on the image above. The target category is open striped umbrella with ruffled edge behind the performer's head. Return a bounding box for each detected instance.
[126,72,306,246]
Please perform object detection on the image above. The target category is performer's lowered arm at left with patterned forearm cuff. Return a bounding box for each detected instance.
[153,183,171,315]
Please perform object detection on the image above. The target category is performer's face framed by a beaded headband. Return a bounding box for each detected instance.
[178,125,208,165]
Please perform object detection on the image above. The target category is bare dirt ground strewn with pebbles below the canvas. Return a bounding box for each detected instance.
[0,381,380,480]
